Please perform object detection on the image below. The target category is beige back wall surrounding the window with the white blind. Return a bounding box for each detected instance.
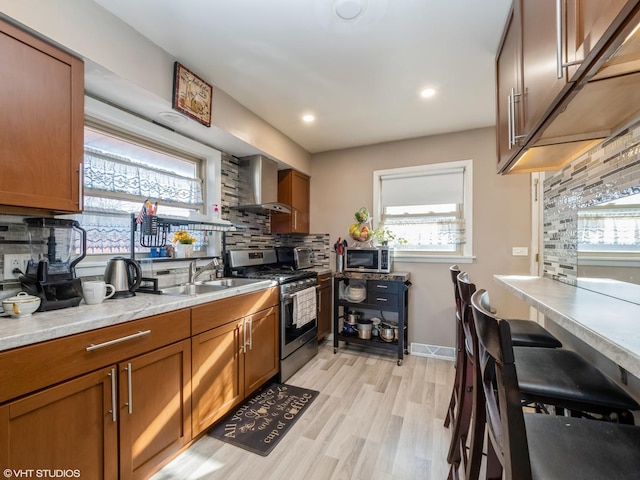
[311,128,531,346]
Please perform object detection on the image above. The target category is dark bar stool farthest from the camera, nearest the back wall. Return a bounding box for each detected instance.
[444,265,562,476]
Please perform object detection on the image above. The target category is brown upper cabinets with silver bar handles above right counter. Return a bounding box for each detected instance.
[496,0,640,173]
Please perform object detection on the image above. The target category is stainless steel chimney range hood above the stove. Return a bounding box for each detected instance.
[234,155,291,213]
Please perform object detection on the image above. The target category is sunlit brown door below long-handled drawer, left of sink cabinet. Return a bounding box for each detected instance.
[118,340,191,479]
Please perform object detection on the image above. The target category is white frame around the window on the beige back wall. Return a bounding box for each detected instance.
[373,159,475,263]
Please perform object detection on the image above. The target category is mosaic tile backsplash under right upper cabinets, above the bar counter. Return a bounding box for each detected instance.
[543,122,640,285]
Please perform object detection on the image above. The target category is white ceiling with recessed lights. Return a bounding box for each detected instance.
[91,0,511,153]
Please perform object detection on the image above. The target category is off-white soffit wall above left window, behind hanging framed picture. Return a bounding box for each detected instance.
[0,0,311,174]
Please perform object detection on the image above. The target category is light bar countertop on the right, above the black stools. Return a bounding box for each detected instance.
[494,275,640,378]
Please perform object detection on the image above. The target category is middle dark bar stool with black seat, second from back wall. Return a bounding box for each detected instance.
[449,273,640,479]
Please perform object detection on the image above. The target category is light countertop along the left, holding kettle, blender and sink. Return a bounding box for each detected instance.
[0,280,276,351]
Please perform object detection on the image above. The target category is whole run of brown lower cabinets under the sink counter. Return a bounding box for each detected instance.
[0,287,279,480]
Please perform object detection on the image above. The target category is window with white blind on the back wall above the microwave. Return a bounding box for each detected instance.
[374,160,472,256]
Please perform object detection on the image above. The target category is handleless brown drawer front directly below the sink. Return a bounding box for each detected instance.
[191,287,279,335]
